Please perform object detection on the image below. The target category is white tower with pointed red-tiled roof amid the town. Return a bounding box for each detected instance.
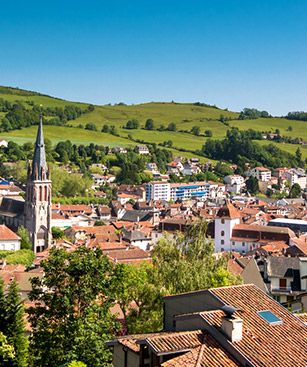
[214,202,241,252]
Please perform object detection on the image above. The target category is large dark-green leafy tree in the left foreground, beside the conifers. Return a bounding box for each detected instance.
[28,247,118,367]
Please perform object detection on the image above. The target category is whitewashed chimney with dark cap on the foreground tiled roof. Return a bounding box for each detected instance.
[222,305,243,343]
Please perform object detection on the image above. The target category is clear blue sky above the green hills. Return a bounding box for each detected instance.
[0,0,307,114]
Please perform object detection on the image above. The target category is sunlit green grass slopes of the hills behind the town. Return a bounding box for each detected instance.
[0,87,307,161]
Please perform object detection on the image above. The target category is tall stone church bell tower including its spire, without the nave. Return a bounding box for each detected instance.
[24,115,51,253]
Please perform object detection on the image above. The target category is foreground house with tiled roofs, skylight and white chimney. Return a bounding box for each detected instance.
[107,284,307,367]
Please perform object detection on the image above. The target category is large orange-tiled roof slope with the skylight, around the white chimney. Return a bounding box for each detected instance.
[205,284,307,367]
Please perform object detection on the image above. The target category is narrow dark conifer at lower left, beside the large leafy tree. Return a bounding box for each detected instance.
[4,278,28,367]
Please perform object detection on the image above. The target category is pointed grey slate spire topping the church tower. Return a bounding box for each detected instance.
[31,114,48,180]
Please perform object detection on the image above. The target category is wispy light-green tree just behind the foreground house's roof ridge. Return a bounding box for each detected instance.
[152,220,239,294]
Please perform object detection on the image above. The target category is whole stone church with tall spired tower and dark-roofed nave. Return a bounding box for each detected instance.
[0,116,52,252]
